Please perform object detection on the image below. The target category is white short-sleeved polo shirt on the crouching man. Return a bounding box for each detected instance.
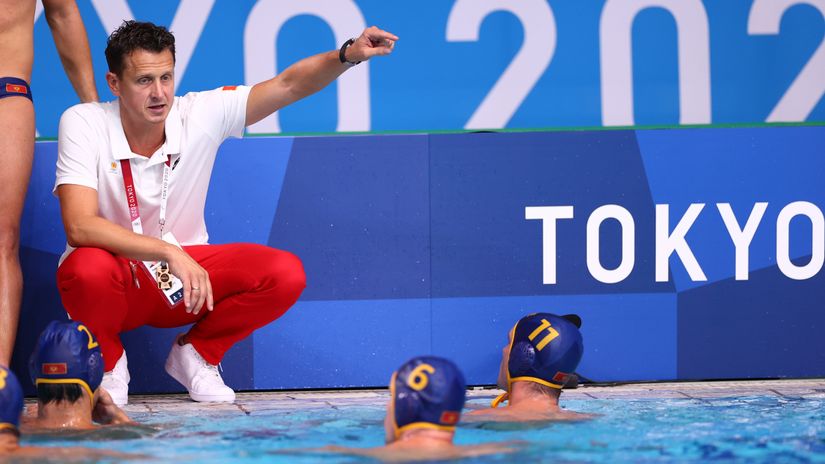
[54,86,251,263]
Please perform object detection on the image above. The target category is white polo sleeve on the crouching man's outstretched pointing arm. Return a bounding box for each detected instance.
[188,85,252,143]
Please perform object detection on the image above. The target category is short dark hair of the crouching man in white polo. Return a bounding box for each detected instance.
[106,21,175,76]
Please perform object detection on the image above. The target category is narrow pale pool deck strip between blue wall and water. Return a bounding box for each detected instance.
[117,379,825,415]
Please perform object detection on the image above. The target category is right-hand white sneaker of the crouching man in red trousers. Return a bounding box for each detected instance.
[166,339,235,403]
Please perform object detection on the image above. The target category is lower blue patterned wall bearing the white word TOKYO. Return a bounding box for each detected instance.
[13,127,825,392]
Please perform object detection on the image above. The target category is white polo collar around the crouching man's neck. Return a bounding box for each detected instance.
[106,98,183,166]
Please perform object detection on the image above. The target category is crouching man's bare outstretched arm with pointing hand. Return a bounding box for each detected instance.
[246,26,398,126]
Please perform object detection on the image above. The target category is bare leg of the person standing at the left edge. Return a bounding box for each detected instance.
[0,97,34,366]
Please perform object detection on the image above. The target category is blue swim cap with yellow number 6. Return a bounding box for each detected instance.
[390,356,467,438]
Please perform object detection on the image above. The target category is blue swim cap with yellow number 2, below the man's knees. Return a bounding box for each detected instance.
[29,321,103,399]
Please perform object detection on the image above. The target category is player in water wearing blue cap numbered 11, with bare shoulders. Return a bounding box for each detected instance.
[465,313,593,422]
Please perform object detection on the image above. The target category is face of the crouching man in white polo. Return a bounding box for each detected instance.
[106,49,175,128]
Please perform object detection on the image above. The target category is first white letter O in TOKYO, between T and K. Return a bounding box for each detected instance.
[587,205,636,284]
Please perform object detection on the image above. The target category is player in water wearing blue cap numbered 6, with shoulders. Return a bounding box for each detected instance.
[316,356,516,462]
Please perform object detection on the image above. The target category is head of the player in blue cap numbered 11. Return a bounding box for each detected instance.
[495,313,584,404]
